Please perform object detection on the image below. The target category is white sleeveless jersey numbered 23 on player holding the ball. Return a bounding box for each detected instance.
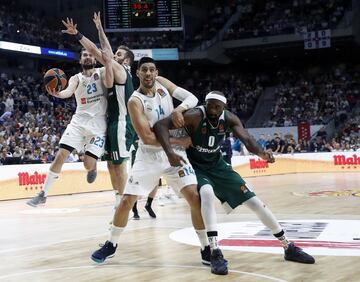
[75,68,107,117]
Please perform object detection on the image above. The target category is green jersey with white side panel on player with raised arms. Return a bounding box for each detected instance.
[108,65,134,122]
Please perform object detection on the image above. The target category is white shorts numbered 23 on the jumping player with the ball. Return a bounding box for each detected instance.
[60,114,106,158]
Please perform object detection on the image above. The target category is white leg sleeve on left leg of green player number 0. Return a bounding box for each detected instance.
[200,184,217,232]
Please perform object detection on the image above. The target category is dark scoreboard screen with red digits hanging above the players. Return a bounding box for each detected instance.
[104,0,183,32]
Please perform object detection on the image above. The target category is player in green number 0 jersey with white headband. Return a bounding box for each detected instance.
[154,91,315,264]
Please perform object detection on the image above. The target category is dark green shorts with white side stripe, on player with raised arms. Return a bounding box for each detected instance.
[104,117,137,164]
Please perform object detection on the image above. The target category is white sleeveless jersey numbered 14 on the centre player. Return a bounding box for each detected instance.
[132,81,174,149]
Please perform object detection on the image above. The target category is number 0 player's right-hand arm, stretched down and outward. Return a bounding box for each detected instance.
[227,111,275,163]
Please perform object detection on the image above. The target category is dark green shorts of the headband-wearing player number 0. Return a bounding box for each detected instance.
[194,158,256,213]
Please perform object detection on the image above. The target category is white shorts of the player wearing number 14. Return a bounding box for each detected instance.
[124,146,197,196]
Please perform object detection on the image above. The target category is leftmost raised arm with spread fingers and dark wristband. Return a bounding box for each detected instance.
[61,18,104,65]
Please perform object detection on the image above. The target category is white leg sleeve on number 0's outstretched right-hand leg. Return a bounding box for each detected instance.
[244,196,282,234]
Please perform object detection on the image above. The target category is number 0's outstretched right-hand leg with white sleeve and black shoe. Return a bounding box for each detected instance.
[244,195,315,264]
